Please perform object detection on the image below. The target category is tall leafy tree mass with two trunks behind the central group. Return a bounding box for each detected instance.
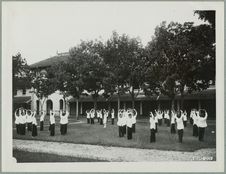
[103,32,143,109]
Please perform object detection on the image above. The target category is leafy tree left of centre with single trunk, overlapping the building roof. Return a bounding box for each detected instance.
[70,41,106,113]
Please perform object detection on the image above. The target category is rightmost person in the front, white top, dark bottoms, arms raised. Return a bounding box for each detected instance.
[198,109,208,141]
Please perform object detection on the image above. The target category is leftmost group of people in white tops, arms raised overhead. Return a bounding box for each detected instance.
[14,108,69,137]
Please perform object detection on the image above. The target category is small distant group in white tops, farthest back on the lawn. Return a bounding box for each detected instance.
[86,108,115,128]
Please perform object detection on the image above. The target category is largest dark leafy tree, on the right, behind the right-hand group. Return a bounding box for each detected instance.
[147,22,215,109]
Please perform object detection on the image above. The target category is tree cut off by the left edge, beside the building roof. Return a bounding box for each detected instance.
[12,53,31,94]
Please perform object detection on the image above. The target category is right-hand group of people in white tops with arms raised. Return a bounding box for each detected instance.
[149,109,208,143]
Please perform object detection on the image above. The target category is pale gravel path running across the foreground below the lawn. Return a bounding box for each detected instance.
[13,139,216,162]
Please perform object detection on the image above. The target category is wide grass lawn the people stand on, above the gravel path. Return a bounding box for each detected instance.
[13,118,216,151]
